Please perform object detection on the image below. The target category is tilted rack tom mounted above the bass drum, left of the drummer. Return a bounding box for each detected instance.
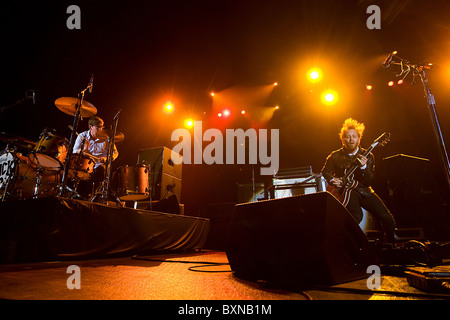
[29,129,69,170]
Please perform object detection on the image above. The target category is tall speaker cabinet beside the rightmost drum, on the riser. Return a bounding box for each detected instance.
[138,147,182,201]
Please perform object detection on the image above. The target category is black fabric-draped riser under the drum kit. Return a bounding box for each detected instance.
[0,197,209,263]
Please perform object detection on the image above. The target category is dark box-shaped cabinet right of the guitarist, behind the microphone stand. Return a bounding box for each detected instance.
[383,154,448,228]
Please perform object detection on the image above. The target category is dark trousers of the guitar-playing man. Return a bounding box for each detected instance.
[347,190,395,243]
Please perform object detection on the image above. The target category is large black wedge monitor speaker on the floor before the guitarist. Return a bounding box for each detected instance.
[226,192,377,289]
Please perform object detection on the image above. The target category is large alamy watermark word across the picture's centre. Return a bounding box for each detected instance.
[171,121,280,175]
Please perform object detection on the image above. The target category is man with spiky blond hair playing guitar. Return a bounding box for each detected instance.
[322,118,395,243]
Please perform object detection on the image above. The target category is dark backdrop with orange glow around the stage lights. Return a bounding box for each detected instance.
[0,0,450,214]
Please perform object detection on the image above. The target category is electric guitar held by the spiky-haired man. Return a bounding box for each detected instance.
[327,132,391,207]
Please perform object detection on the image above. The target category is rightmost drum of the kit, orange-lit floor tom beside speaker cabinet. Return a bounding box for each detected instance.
[116,164,150,201]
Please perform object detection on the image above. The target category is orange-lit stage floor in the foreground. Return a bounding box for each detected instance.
[0,250,450,302]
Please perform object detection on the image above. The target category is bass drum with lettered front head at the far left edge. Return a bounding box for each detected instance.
[0,152,60,200]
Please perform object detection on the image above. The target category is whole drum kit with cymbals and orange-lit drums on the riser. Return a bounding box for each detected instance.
[0,97,151,204]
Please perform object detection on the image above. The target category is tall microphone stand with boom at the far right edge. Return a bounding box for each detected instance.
[386,51,450,197]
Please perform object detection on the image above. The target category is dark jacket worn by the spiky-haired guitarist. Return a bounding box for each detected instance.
[321,148,375,195]
